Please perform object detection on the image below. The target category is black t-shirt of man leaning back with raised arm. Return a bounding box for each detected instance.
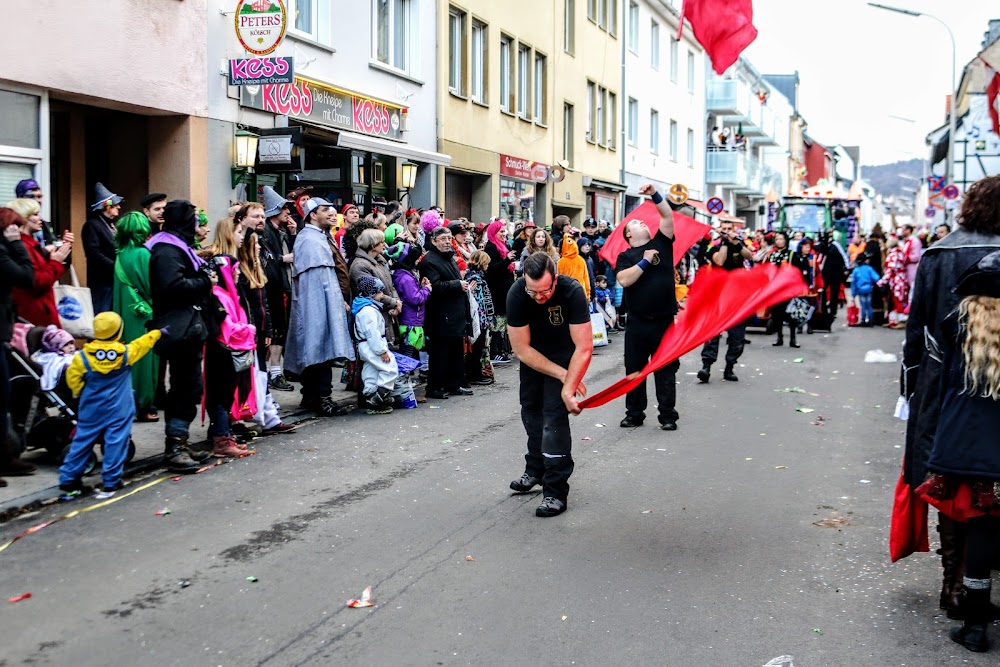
[615,231,677,320]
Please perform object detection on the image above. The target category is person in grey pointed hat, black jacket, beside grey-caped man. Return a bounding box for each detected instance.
[260,186,295,391]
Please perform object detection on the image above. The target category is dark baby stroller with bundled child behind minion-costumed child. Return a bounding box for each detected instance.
[6,322,135,475]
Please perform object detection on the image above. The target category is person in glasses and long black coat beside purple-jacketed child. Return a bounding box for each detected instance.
[418,227,472,399]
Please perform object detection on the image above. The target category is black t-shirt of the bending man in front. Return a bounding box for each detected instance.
[507,276,590,368]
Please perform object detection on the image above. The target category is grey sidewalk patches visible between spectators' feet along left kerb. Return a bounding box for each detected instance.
[0,385,357,522]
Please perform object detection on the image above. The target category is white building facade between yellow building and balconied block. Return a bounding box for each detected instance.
[622,0,707,210]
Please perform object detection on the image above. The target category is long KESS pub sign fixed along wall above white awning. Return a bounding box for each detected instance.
[240,77,406,140]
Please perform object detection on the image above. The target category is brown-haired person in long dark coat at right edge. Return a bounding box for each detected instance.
[904,176,1000,618]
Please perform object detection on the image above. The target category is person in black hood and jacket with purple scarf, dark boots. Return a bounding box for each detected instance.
[147,200,218,473]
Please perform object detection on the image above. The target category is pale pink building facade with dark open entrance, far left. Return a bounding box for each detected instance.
[0,0,208,278]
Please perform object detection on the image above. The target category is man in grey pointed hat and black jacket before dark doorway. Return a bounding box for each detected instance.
[80,183,122,315]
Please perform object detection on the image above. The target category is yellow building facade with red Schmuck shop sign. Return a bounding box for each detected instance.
[437,0,624,226]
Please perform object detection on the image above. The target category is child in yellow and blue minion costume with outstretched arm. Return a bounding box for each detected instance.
[59,312,163,497]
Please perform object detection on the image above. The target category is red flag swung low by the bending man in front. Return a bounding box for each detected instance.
[580,264,808,408]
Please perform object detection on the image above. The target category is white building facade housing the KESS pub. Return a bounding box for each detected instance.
[207,0,449,222]
